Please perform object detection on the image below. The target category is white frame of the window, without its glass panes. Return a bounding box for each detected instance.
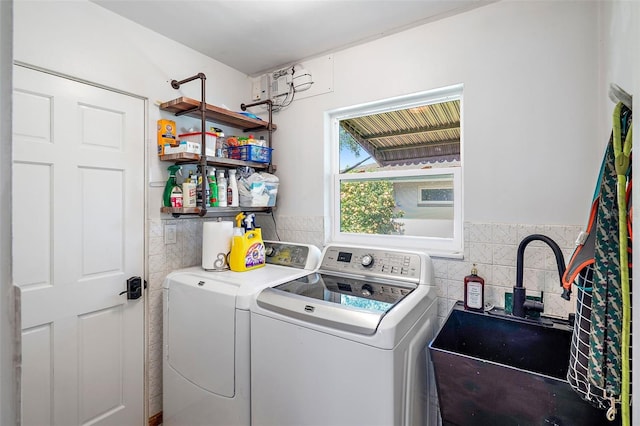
[325,84,464,258]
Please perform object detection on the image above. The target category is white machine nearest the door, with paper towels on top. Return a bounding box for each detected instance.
[162,241,320,426]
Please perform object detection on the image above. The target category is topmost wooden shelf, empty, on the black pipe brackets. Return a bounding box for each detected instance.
[160,96,276,132]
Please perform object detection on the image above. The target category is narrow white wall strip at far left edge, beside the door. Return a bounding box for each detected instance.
[0,0,18,426]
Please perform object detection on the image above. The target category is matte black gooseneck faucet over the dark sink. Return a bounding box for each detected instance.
[512,234,565,318]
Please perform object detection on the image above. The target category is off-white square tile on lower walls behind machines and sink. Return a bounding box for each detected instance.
[147,215,582,415]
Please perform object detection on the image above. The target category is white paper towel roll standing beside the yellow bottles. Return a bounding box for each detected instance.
[202,221,233,271]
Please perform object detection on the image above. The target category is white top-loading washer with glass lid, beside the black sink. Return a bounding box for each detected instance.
[250,245,437,426]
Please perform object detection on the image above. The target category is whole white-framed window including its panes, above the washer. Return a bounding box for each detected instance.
[326,85,462,254]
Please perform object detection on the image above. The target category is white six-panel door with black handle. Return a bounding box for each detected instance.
[12,66,145,426]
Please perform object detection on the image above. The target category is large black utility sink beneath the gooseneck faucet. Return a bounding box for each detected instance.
[429,302,619,426]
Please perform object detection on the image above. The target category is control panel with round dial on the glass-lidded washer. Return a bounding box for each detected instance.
[320,246,423,282]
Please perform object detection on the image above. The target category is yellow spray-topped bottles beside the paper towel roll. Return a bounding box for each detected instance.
[229,213,266,272]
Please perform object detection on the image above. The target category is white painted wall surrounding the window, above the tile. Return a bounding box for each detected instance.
[274,1,604,228]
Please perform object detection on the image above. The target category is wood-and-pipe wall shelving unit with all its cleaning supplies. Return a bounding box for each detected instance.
[158,73,278,217]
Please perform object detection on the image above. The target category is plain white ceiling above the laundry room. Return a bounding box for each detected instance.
[91,0,496,76]
